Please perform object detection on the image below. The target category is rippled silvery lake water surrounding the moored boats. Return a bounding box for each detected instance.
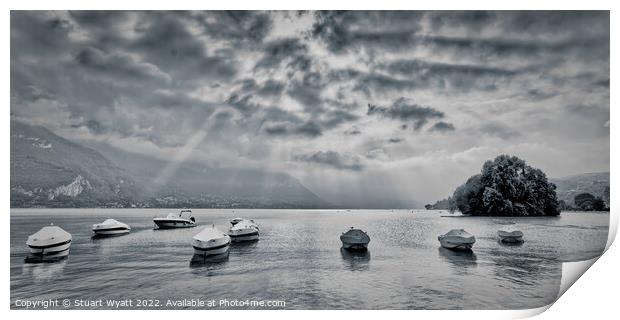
[10,209,609,309]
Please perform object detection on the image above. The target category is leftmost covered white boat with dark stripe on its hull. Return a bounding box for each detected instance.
[26,223,72,262]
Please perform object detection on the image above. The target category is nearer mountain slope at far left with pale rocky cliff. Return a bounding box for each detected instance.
[11,121,136,207]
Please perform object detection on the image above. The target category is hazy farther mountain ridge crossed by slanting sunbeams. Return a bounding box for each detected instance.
[92,143,329,208]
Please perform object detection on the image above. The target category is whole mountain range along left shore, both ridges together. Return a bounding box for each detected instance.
[11,121,329,208]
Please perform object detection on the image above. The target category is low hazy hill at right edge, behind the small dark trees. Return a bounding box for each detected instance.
[550,172,610,206]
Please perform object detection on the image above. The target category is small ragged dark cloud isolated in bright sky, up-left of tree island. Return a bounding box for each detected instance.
[366,98,444,130]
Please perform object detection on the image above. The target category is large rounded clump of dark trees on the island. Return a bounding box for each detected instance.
[450,155,560,216]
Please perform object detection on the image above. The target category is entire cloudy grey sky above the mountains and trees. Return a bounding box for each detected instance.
[11,11,610,203]
